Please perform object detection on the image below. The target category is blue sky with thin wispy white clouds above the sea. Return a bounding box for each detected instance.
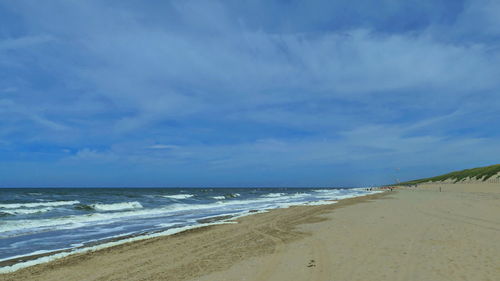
[0,0,500,187]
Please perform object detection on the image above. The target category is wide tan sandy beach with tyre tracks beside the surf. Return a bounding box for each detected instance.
[0,184,500,281]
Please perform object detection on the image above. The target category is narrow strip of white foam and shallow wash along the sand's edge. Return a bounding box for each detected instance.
[0,190,383,277]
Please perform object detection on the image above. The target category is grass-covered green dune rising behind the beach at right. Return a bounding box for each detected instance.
[401,164,500,184]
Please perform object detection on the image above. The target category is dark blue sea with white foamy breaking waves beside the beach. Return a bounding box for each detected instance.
[0,188,376,272]
